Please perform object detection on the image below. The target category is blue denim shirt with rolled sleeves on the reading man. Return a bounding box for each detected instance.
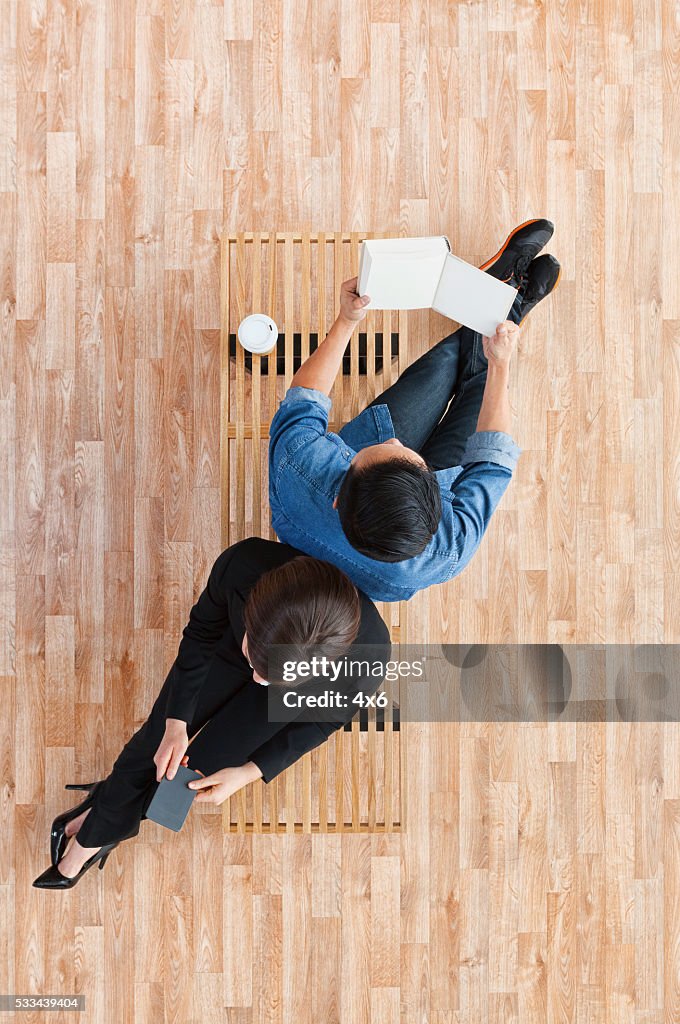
[269,387,520,601]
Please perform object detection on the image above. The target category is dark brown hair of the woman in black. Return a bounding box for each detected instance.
[244,555,362,681]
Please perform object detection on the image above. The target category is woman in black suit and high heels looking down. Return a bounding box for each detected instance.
[33,537,389,889]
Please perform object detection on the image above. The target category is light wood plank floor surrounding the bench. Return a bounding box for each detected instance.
[0,0,680,1024]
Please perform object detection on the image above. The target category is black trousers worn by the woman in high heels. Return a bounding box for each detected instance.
[78,656,282,847]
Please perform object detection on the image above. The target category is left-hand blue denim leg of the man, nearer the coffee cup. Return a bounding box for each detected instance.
[340,328,471,452]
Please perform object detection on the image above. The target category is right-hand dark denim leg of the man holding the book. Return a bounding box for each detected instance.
[420,294,522,469]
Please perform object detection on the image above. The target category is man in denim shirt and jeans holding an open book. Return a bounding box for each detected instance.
[269,219,559,601]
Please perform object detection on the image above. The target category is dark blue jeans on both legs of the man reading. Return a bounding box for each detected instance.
[368,295,521,469]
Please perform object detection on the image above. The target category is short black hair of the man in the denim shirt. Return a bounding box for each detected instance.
[337,456,441,562]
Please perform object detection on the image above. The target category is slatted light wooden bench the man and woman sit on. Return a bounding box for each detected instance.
[220,231,408,833]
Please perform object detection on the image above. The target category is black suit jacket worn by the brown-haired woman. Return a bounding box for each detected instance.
[161,537,390,782]
